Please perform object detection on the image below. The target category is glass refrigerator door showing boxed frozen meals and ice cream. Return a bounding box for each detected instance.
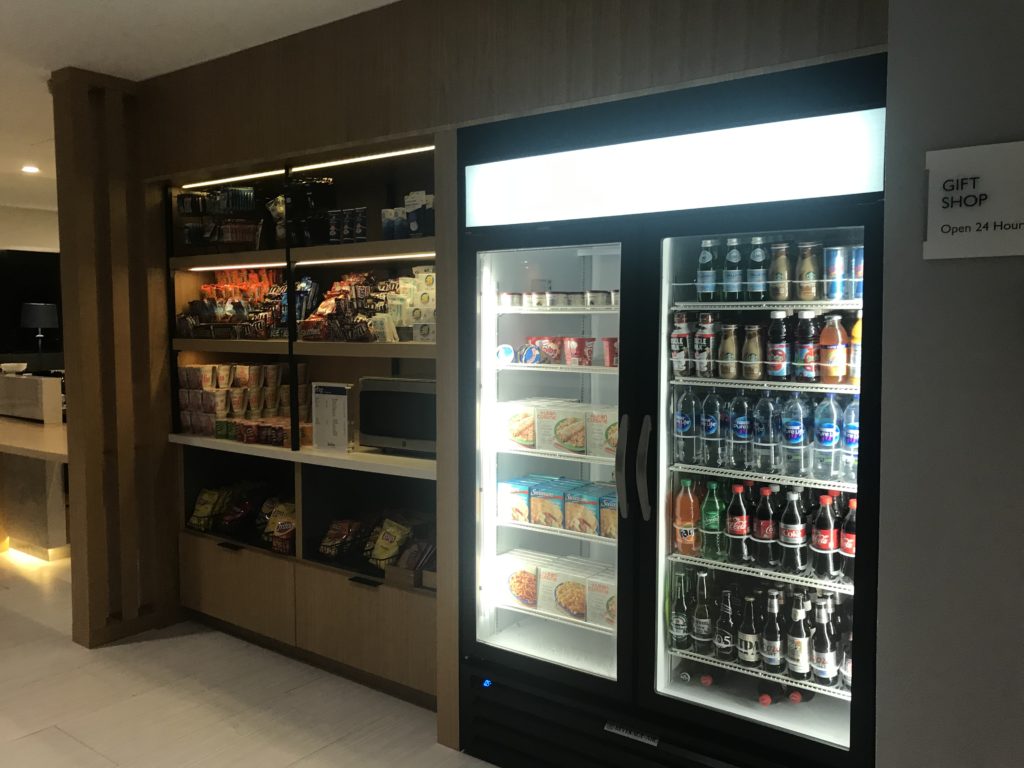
[475,244,622,680]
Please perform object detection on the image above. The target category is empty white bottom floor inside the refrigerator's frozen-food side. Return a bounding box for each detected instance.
[480,616,615,680]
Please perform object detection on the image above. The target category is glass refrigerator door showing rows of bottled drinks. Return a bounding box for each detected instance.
[652,227,870,749]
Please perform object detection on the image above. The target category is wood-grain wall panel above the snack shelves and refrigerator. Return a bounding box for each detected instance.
[139,0,887,177]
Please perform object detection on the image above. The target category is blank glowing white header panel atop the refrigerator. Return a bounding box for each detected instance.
[466,109,886,226]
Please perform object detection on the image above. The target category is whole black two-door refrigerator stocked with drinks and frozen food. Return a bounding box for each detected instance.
[459,56,885,768]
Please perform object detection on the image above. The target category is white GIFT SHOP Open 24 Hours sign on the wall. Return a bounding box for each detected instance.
[925,141,1024,259]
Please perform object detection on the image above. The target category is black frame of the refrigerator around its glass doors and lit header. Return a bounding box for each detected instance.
[458,54,886,768]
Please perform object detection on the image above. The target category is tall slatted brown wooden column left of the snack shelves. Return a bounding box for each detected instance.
[50,69,178,646]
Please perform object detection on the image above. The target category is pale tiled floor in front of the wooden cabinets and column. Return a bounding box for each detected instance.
[0,552,487,768]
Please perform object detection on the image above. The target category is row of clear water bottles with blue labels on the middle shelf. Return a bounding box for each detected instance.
[673,386,860,482]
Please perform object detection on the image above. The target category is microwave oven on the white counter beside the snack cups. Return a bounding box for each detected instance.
[359,377,437,454]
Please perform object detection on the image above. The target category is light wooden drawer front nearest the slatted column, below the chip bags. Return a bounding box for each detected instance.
[178,530,295,645]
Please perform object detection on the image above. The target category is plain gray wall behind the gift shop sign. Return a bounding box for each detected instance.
[878,0,1024,768]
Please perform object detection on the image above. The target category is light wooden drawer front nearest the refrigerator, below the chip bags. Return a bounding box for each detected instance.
[295,563,437,695]
